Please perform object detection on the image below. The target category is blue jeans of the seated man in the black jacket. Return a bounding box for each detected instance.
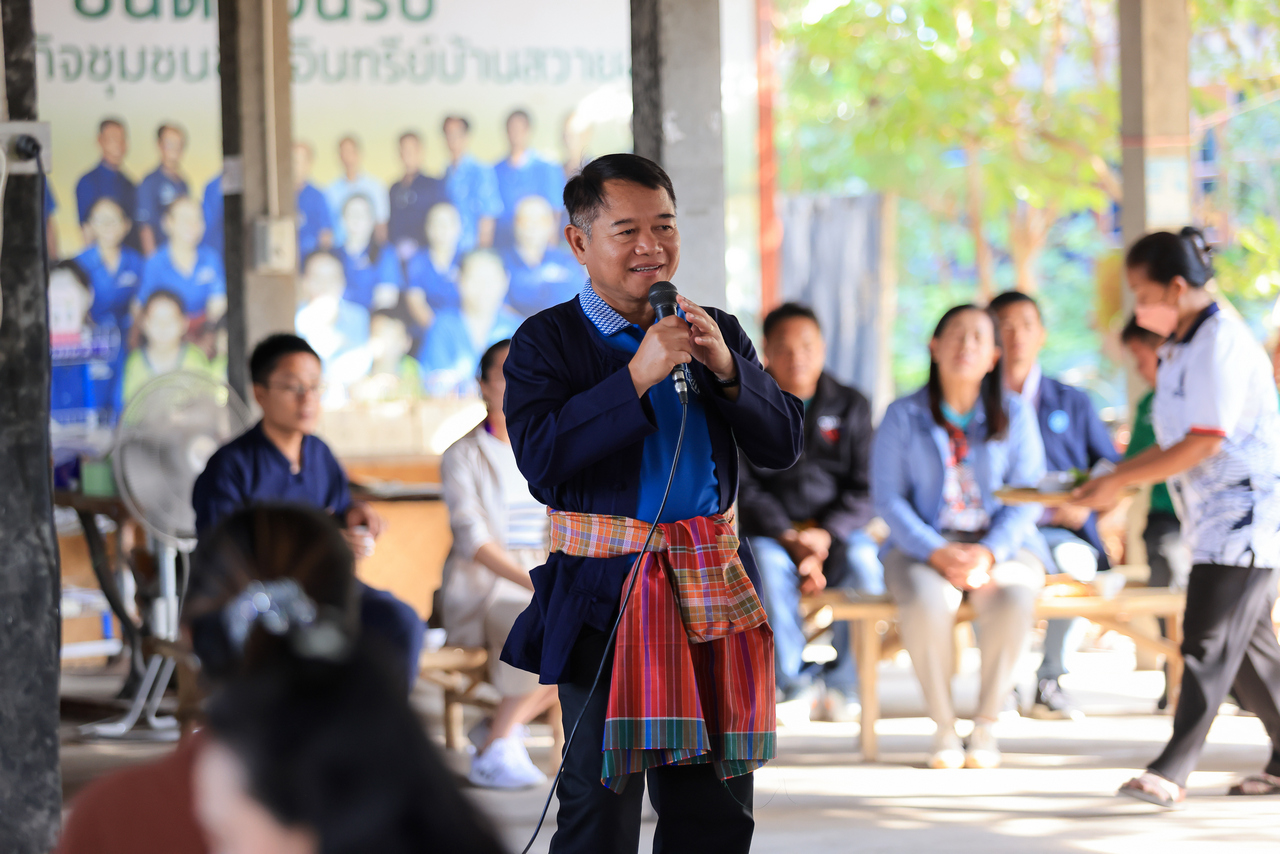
[750,530,884,699]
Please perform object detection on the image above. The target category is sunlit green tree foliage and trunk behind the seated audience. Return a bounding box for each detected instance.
[777,0,1120,391]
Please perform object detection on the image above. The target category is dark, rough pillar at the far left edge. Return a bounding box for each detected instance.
[0,0,61,854]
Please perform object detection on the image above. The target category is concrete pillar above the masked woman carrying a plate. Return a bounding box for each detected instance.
[1119,0,1192,246]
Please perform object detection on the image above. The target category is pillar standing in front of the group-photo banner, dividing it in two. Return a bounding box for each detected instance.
[218,0,297,396]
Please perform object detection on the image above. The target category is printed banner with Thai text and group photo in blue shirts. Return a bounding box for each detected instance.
[36,0,631,460]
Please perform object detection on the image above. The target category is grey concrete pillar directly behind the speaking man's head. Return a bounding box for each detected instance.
[631,0,724,306]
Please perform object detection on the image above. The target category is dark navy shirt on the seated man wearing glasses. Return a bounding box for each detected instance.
[191,421,351,536]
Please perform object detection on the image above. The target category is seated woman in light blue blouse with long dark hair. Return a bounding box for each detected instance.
[872,305,1044,768]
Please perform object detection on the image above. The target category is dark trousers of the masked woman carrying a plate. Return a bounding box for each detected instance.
[1149,563,1280,786]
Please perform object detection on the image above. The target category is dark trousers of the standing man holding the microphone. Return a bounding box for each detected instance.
[550,629,755,854]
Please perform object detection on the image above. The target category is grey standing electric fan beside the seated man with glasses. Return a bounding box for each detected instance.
[81,371,250,739]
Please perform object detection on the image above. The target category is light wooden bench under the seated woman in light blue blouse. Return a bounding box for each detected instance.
[801,588,1187,762]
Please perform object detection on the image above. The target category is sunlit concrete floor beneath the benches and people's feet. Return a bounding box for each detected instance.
[64,645,1280,854]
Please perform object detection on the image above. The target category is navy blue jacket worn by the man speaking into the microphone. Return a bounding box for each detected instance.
[502,297,804,685]
